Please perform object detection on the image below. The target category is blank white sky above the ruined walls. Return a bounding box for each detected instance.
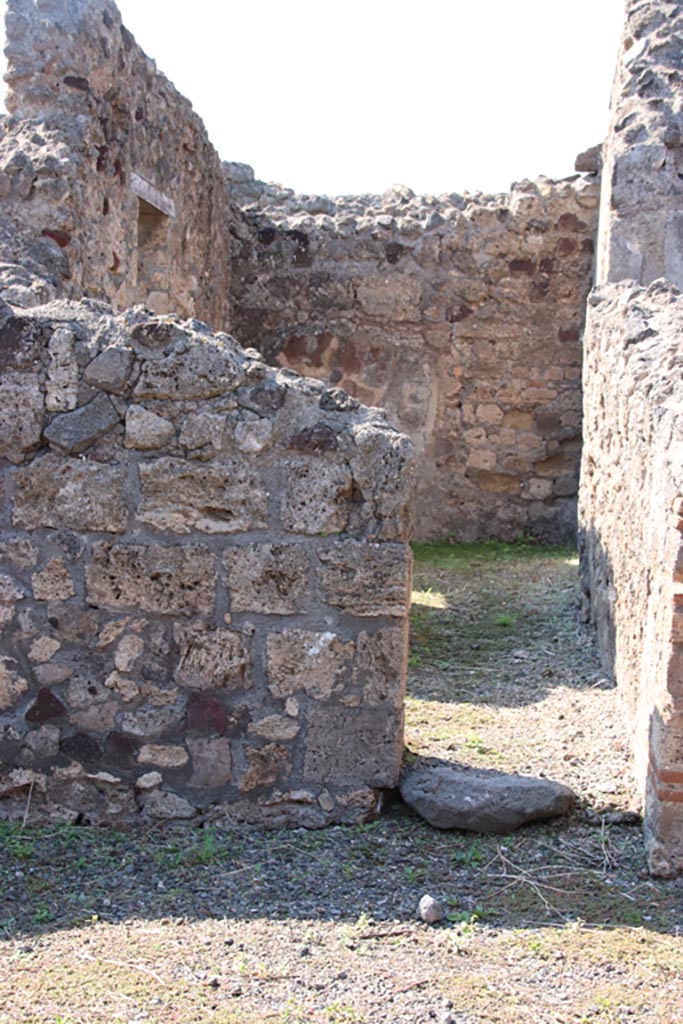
[0,0,624,195]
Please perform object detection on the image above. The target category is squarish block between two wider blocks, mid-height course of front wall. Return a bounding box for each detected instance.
[223,544,310,615]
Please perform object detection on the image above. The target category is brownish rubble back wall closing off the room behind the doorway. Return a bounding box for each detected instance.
[226,164,598,541]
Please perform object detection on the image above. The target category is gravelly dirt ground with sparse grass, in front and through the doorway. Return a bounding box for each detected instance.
[0,544,683,1024]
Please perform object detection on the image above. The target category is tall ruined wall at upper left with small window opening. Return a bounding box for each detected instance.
[0,0,229,329]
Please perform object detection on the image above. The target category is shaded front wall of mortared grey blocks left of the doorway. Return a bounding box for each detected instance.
[0,300,413,826]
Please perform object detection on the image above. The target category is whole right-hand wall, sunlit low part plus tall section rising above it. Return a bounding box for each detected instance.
[580,0,683,873]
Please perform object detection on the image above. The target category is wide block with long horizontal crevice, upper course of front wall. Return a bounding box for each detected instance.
[137,459,267,534]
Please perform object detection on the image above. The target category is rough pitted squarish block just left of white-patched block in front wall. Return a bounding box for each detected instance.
[173,625,251,690]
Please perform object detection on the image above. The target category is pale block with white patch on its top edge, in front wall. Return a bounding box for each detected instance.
[266,630,353,699]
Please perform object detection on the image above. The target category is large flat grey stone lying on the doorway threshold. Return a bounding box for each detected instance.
[400,765,574,833]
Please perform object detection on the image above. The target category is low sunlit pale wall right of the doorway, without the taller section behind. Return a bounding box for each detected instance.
[580,282,683,874]
